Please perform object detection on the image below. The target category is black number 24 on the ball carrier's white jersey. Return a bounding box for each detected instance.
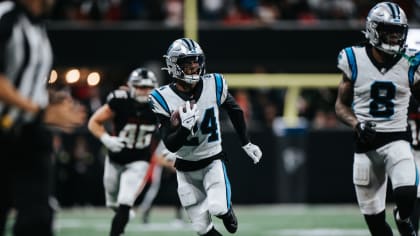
[186,107,219,146]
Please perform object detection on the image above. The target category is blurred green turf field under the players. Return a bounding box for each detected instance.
[4,205,404,236]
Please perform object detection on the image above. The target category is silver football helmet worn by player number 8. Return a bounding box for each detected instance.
[364,2,408,55]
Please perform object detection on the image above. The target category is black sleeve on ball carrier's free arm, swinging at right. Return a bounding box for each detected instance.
[222,93,249,146]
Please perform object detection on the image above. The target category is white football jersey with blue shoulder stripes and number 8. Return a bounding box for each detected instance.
[337,46,420,132]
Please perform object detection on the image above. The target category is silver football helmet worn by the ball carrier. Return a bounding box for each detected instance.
[162,38,205,84]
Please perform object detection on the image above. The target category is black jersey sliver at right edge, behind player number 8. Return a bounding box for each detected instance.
[408,97,420,150]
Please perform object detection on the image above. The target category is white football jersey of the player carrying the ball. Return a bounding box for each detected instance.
[150,74,228,161]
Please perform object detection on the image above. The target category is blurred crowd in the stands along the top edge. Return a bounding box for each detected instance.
[53,0,420,26]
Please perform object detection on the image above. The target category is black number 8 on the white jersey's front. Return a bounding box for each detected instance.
[369,81,395,117]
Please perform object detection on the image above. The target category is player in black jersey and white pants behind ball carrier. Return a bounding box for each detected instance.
[88,68,157,236]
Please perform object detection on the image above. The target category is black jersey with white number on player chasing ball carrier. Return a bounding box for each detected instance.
[107,90,157,164]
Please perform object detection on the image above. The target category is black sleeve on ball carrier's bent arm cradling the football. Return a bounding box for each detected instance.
[157,114,190,152]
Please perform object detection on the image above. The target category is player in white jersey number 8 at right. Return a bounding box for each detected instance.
[335,2,420,236]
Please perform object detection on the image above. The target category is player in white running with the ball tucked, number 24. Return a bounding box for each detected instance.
[150,38,262,236]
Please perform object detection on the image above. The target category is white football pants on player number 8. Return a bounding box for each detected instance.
[353,140,416,215]
